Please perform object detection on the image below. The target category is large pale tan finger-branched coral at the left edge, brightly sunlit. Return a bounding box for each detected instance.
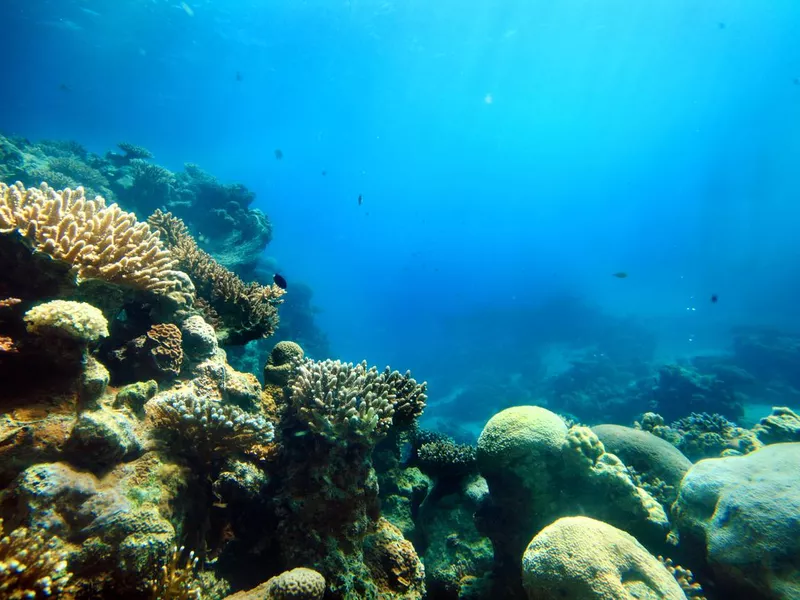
[0,183,193,305]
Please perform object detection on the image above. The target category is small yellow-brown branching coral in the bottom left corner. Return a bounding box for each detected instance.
[0,519,72,600]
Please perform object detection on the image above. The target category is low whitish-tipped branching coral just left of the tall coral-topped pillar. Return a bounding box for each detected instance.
[145,388,275,464]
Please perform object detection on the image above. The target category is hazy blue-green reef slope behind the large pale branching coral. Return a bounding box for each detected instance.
[0,135,272,279]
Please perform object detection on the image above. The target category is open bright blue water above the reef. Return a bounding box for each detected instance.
[0,0,800,422]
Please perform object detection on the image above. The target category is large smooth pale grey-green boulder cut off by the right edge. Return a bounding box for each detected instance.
[674,442,800,600]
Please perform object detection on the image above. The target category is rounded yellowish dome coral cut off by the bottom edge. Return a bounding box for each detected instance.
[522,517,686,600]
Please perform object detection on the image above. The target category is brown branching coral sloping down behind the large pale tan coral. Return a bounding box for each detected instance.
[148,210,284,344]
